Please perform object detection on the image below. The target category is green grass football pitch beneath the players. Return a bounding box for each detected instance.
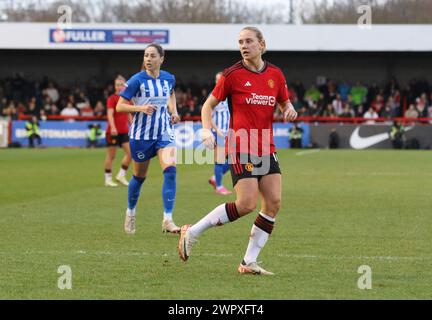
[0,149,432,299]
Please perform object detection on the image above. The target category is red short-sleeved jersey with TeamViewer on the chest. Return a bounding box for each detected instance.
[212,61,289,156]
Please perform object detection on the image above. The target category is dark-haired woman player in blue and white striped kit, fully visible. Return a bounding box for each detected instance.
[116,44,180,234]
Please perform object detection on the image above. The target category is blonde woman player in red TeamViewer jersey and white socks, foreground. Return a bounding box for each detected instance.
[178,27,297,275]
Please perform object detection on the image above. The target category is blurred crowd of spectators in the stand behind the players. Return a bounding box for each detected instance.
[0,73,432,121]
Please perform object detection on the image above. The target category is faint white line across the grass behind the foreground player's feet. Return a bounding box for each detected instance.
[0,250,432,261]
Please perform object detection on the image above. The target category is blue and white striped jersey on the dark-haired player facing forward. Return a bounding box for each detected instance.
[120,70,175,140]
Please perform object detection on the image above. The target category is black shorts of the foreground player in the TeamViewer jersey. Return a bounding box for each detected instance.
[228,152,281,187]
